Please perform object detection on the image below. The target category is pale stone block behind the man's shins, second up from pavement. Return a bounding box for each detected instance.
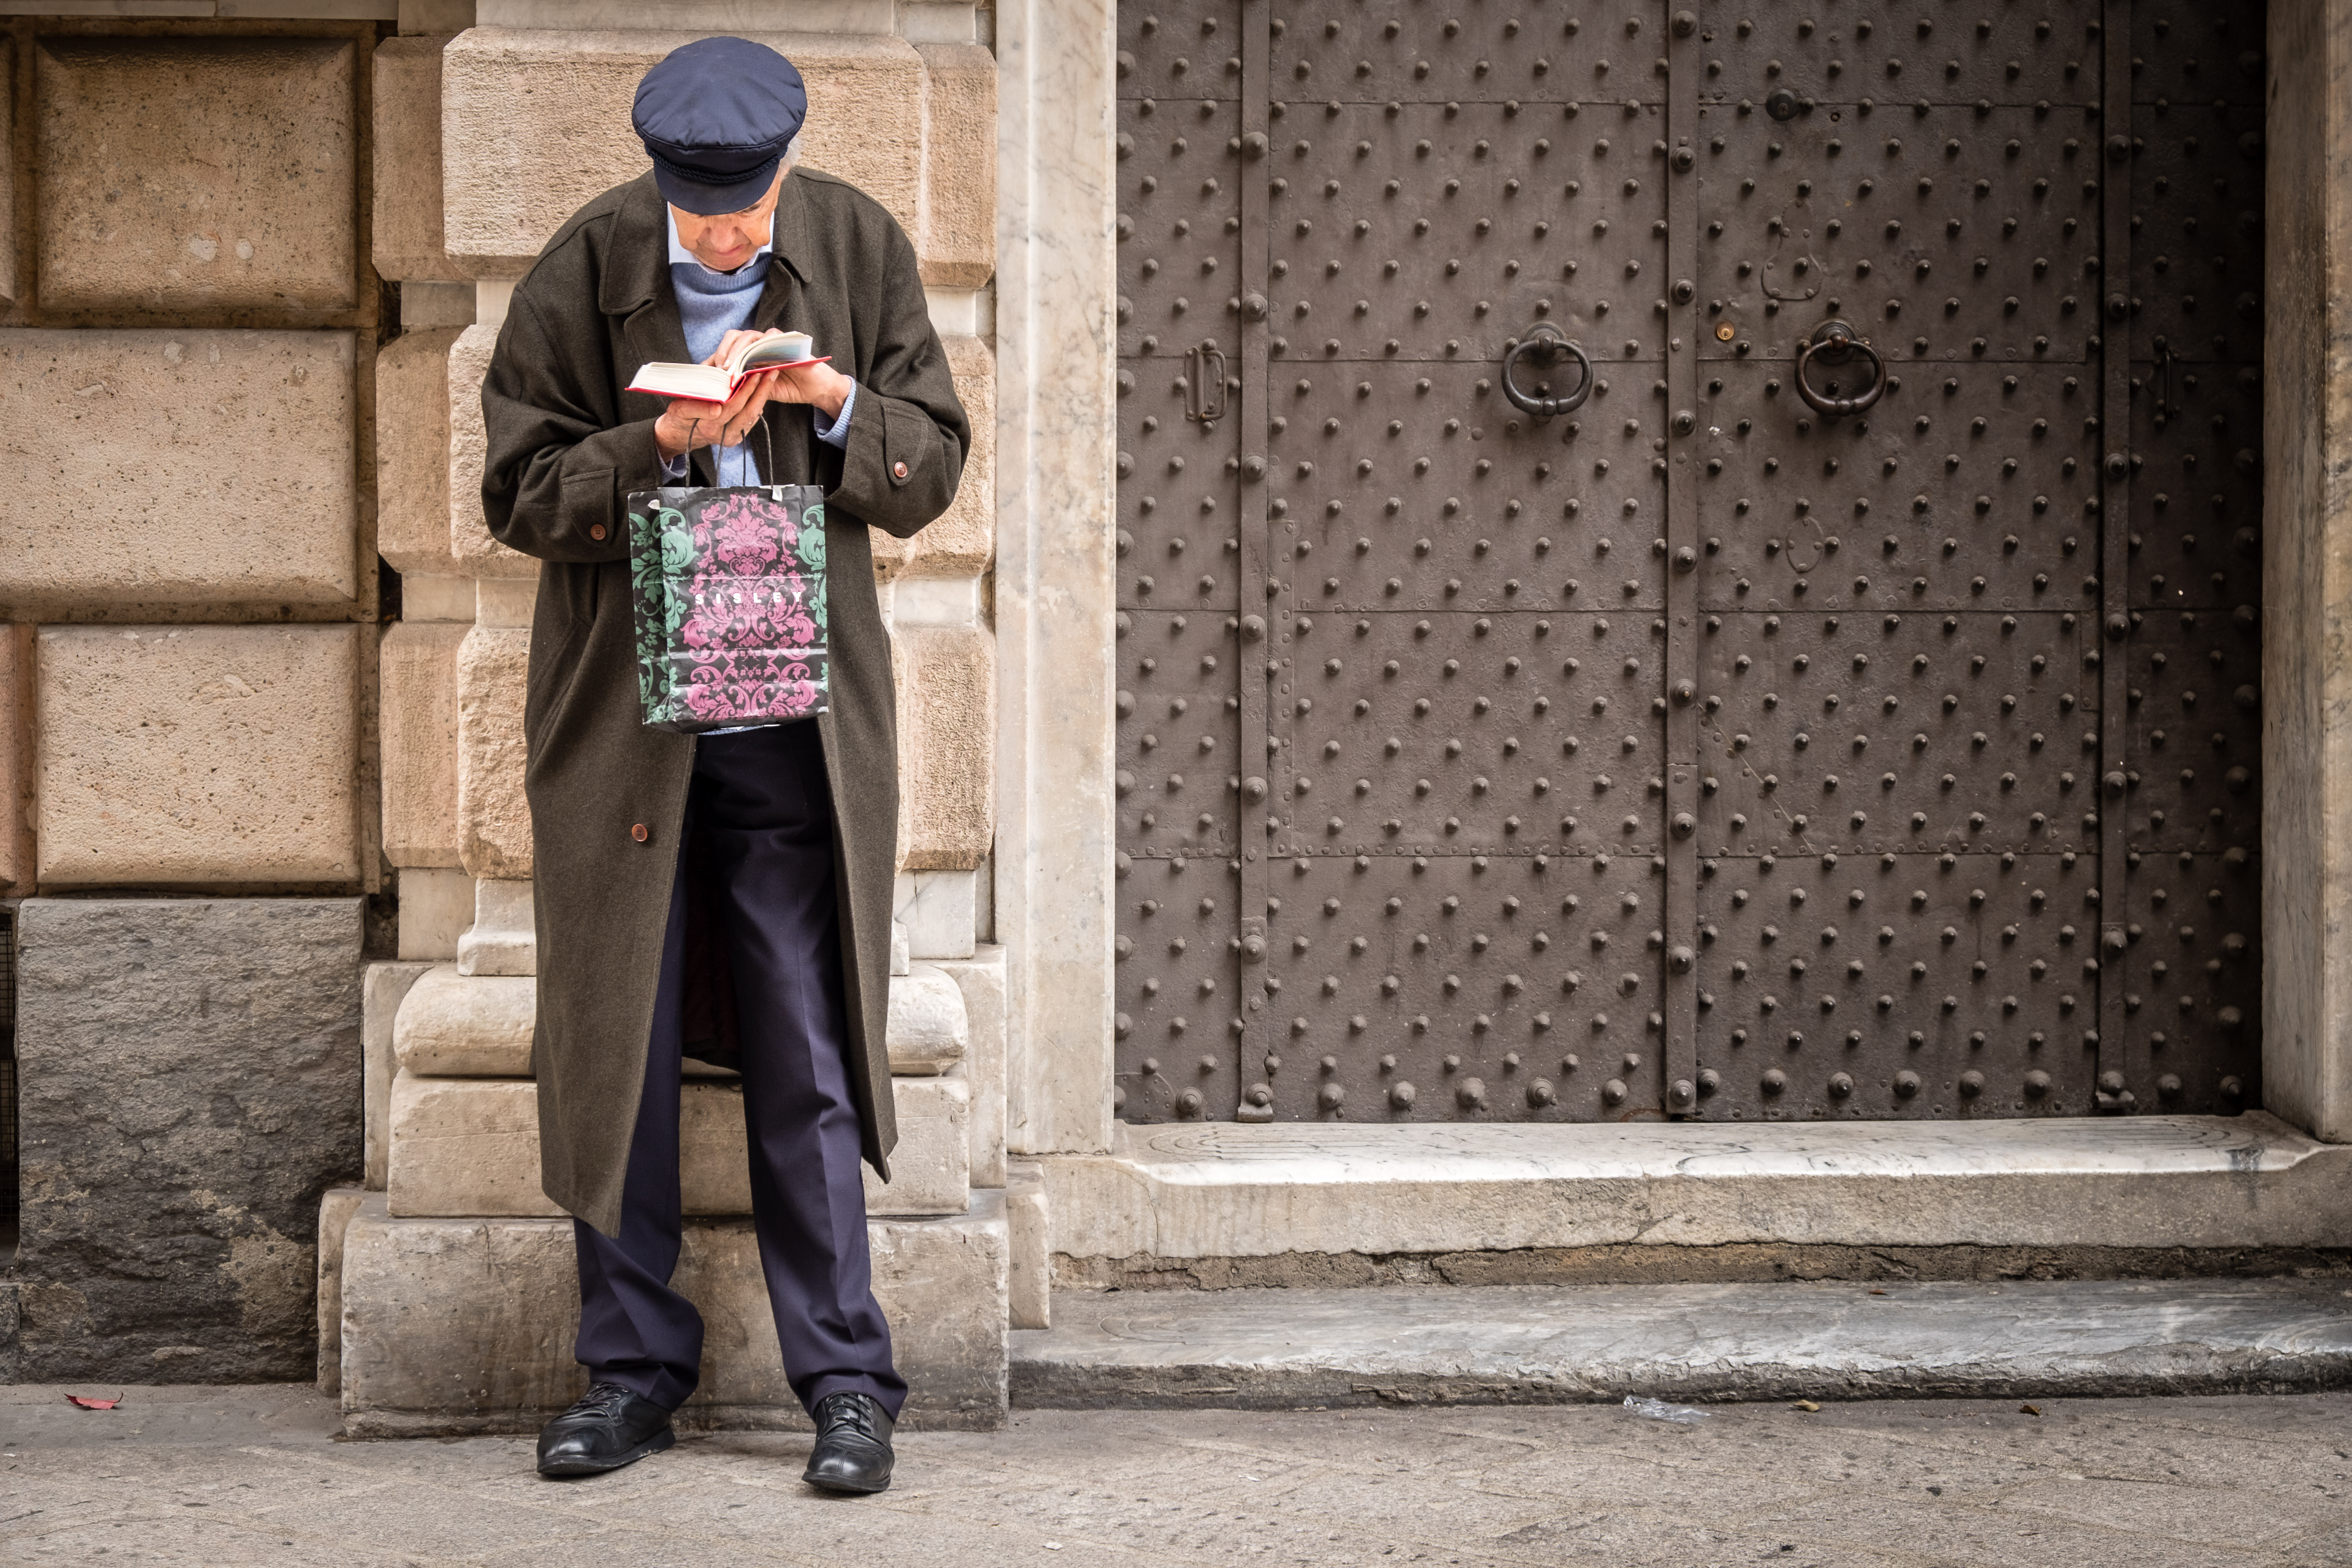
[386,1070,971,1215]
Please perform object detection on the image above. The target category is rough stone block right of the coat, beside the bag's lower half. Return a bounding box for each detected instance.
[891,625,997,870]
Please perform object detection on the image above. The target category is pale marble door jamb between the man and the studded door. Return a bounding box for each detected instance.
[995,0,1117,1152]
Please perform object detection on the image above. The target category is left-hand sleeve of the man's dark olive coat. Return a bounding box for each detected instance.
[482,285,663,562]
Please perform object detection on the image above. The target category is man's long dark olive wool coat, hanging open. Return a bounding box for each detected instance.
[482,169,971,1234]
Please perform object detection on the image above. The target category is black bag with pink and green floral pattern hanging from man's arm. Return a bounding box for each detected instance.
[628,484,826,736]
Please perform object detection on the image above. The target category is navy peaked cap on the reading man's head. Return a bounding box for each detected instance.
[630,38,809,216]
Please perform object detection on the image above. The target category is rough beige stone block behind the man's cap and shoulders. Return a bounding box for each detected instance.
[442,28,927,278]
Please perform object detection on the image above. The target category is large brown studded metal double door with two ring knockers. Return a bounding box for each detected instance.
[1117,0,2263,1122]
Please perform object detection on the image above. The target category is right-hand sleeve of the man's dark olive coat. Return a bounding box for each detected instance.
[826,219,971,538]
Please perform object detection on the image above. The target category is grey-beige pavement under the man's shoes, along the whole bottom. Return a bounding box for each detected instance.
[0,1385,2352,1568]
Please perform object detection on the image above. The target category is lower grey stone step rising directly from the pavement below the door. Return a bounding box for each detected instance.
[1011,1279,2352,1410]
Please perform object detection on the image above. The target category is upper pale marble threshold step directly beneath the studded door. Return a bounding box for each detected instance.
[1040,1112,2352,1288]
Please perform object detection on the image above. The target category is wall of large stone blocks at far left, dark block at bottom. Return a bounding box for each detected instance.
[0,15,388,1382]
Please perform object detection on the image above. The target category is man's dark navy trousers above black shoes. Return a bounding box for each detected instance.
[572,719,906,1417]
